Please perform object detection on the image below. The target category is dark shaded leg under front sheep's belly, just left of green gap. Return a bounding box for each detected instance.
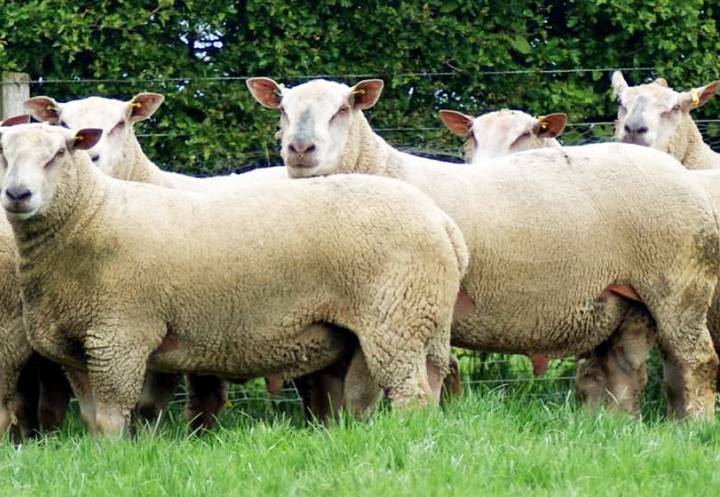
[185,374,227,432]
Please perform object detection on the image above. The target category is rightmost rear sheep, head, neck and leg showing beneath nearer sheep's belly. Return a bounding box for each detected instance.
[576,71,720,414]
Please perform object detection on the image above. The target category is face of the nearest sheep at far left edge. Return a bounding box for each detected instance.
[0,124,102,219]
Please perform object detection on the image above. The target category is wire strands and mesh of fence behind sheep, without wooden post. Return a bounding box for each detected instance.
[12,67,720,406]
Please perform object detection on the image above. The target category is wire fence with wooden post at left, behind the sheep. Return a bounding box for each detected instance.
[0,68,720,410]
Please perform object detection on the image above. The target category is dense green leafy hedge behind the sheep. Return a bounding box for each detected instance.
[0,0,720,174]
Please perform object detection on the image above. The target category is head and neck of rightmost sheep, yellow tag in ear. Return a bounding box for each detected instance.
[612,71,720,169]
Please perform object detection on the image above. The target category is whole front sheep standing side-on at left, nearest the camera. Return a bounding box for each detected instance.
[0,124,468,435]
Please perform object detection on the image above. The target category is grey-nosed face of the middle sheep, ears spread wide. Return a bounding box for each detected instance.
[247,78,383,178]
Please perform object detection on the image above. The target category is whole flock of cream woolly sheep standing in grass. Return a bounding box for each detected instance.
[0,68,720,441]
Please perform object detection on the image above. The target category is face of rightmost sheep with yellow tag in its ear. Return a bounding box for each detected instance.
[612,71,720,151]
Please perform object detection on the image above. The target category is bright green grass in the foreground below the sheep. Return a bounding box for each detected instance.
[0,386,720,497]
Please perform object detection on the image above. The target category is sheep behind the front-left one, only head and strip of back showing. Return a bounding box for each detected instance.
[23,93,287,191]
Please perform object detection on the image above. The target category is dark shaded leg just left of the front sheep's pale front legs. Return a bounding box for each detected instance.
[37,358,71,431]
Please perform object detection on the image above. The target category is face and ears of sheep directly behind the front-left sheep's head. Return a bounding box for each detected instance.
[24,93,164,176]
